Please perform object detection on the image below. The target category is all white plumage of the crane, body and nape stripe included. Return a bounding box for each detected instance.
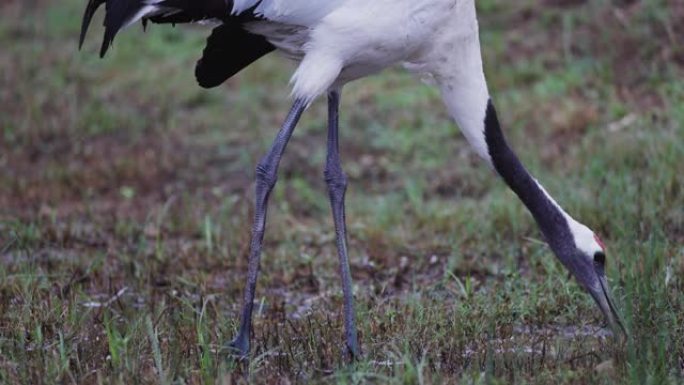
[117,0,602,268]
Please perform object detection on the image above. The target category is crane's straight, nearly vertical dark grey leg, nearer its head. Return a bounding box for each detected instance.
[325,91,360,358]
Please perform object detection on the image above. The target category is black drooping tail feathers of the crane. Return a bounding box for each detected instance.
[79,0,275,88]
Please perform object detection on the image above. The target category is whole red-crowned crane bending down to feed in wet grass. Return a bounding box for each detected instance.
[80,0,626,357]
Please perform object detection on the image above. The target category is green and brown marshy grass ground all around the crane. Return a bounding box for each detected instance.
[0,0,684,384]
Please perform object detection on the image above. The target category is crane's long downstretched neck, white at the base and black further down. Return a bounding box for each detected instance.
[423,0,583,252]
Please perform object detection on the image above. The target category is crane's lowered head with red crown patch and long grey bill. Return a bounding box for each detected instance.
[552,222,627,337]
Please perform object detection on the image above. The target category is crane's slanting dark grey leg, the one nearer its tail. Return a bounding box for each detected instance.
[229,99,306,358]
